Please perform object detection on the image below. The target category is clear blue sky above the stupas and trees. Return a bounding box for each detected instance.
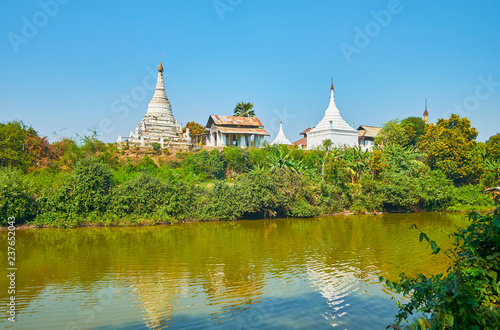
[0,0,500,141]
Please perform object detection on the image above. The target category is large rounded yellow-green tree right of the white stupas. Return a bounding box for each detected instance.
[417,115,482,184]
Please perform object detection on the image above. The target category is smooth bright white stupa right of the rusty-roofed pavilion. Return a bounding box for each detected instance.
[307,81,358,149]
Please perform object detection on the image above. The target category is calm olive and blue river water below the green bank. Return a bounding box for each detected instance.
[0,213,467,329]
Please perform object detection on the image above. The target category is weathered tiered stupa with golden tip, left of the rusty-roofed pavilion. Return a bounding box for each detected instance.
[118,61,190,148]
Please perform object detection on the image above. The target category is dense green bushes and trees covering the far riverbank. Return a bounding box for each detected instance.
[0,115,500,227]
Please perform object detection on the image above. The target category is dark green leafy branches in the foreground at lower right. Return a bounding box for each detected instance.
[380,187,500,329]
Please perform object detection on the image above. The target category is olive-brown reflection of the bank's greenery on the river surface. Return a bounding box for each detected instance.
[0,213,465,326]
